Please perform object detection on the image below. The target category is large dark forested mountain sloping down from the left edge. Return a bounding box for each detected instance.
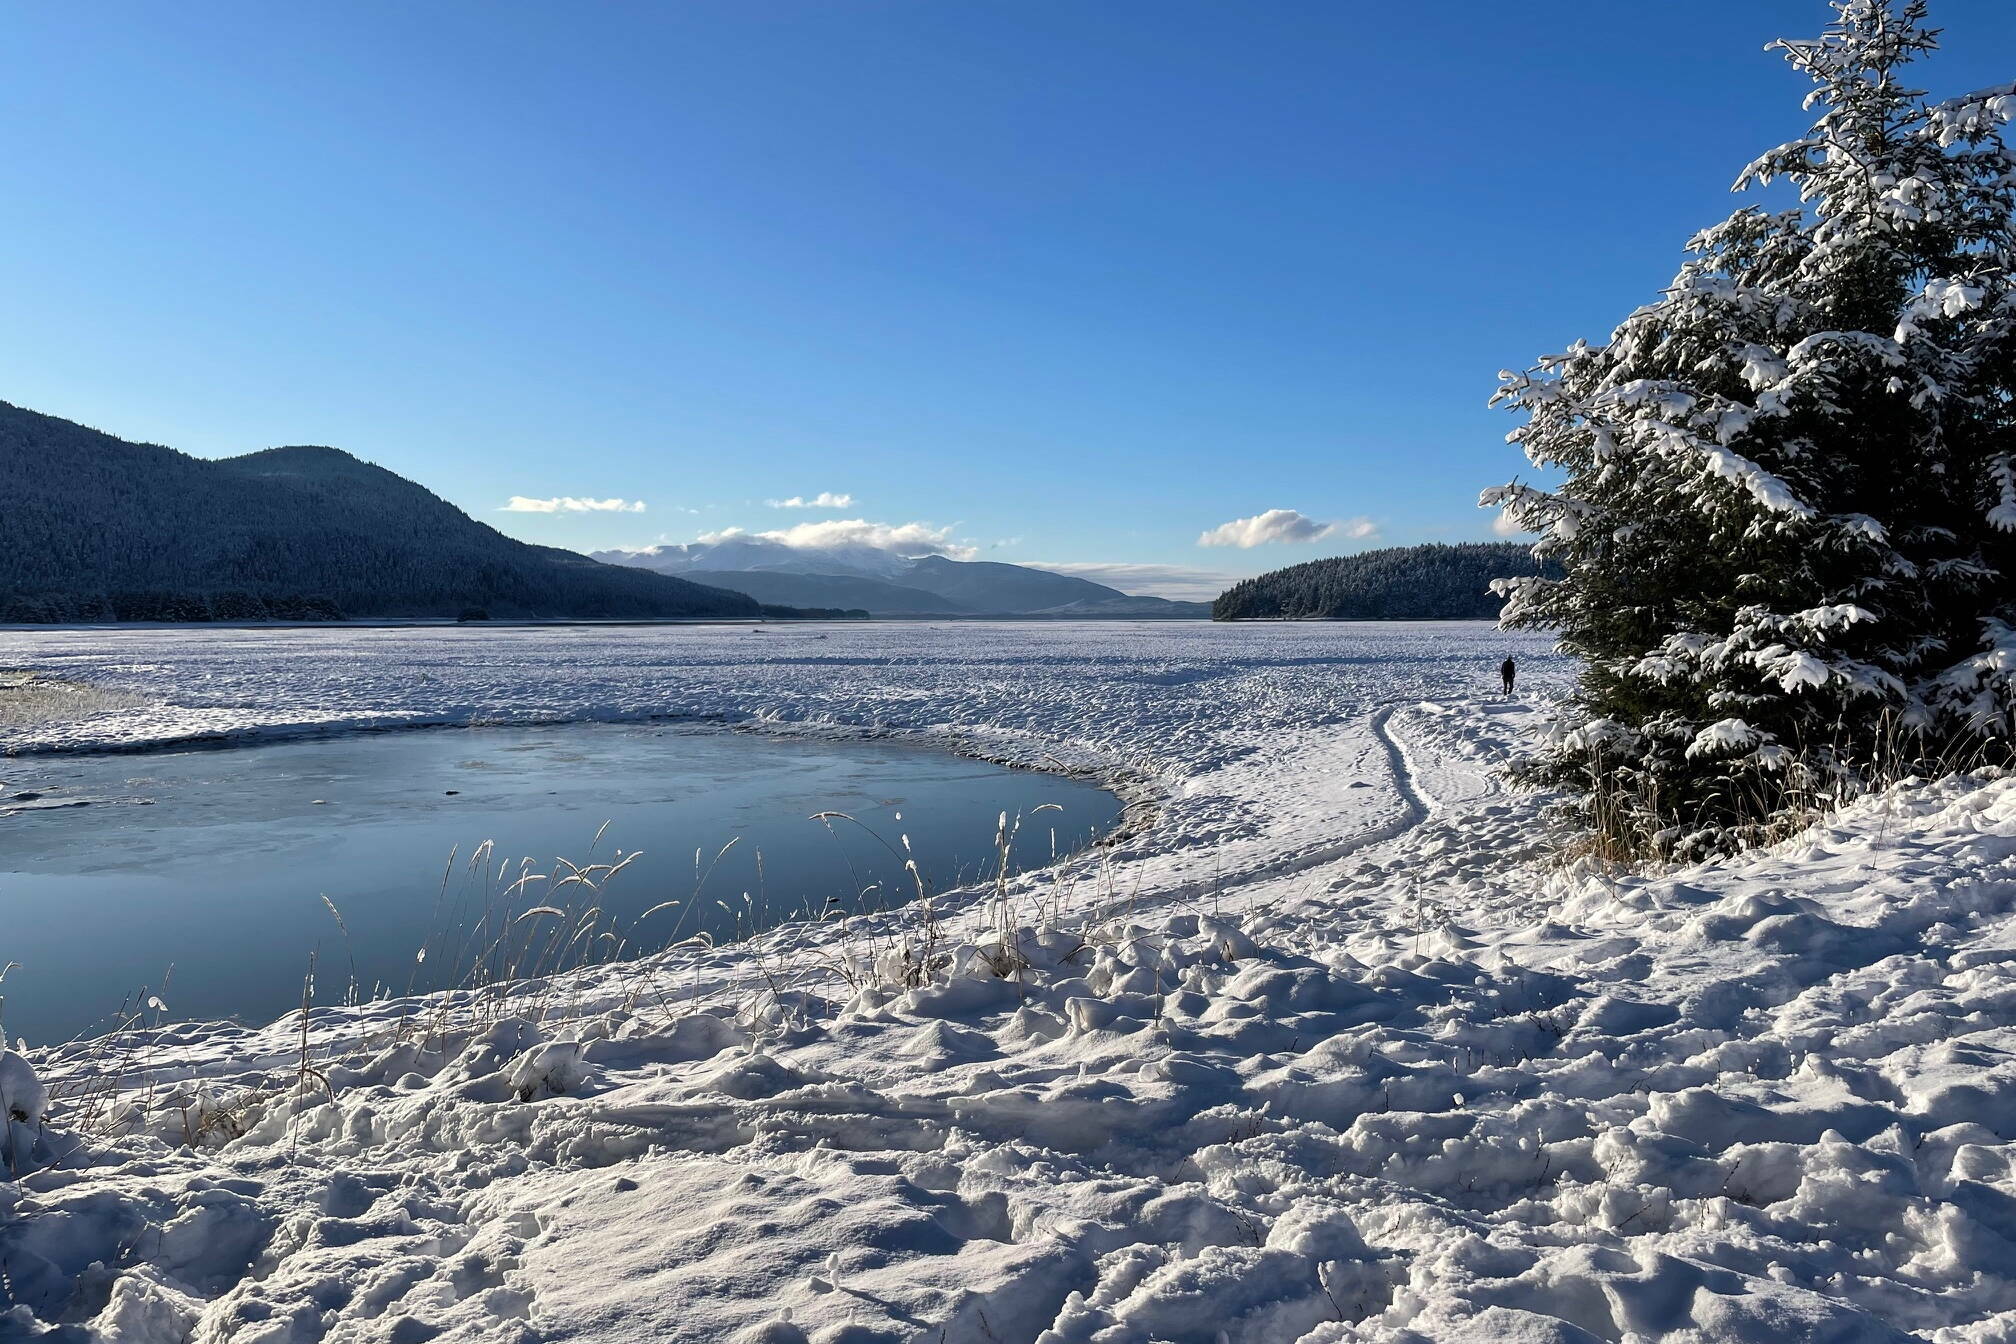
[0,401,758,621]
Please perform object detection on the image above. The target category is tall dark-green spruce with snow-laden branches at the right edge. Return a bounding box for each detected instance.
[1484,0,2016,858]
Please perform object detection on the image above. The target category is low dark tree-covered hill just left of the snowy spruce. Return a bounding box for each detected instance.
[1212,542,1540,621]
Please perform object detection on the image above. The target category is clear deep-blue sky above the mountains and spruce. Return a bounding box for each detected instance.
[0,0,2016,600]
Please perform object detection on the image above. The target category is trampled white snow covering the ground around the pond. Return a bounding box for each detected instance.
[0,625,2016,1344]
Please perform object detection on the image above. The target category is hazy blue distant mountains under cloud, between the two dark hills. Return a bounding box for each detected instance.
[593,534,1210,619]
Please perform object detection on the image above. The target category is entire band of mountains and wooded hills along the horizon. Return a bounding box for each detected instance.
[0,401,1538,623]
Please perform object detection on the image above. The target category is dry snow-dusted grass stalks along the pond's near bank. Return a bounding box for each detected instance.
[38,804,1133,1147]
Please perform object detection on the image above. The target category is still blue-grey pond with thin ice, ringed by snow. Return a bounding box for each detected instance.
[0,723,1121,1042]
